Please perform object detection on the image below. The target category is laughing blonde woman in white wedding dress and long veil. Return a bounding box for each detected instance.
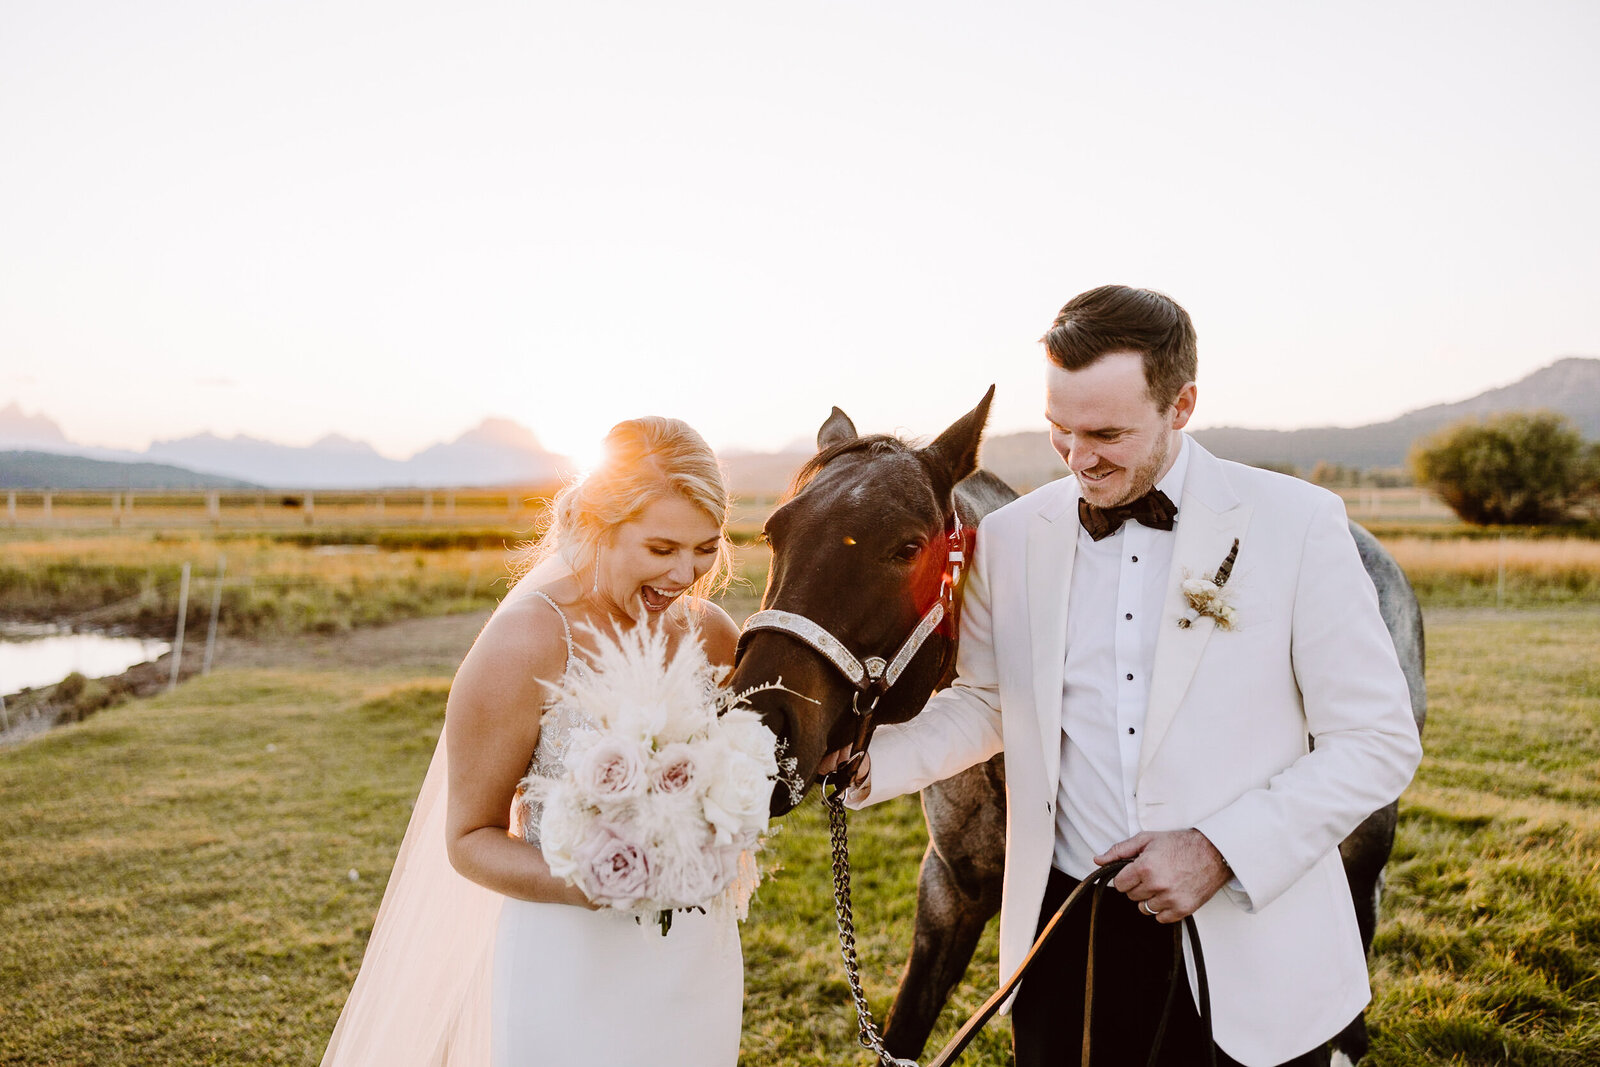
[322,418,744,1067]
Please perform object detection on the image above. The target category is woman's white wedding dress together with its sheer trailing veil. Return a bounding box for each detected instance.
[322,579,744,1067]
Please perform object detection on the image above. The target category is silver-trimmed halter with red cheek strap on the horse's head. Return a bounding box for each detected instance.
[739,510,973,752]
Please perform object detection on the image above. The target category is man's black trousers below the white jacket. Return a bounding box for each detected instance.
[1011,869,1330,1067]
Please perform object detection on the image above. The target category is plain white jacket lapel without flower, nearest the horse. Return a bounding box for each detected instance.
[1024,482,1078,783]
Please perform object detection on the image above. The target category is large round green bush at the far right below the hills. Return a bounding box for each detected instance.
[1410,411,1592,526]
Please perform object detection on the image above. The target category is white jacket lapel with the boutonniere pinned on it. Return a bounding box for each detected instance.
[1139,438,1251,776]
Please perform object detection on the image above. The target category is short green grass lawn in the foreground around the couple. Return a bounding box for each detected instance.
[0,609,1600,1067]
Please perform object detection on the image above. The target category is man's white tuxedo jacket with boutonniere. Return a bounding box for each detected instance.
[866,440,1422,1067]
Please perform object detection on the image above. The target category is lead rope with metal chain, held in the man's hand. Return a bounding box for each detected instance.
[822,777,1216,1067]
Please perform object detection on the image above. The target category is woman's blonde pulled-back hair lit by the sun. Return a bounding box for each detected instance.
[512,414,733,597]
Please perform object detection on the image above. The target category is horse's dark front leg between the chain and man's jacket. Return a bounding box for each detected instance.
[883,841,1000,1059]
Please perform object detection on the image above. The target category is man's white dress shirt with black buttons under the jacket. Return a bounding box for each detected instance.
[1053,435,1189,878]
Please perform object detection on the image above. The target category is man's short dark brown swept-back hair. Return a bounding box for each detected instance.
[1040,285,1198,411]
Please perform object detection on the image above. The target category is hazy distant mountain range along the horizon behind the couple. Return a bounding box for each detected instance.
[0,357,1600,494]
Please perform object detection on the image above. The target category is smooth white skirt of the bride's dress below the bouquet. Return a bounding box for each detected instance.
[490,899,744,1067]
